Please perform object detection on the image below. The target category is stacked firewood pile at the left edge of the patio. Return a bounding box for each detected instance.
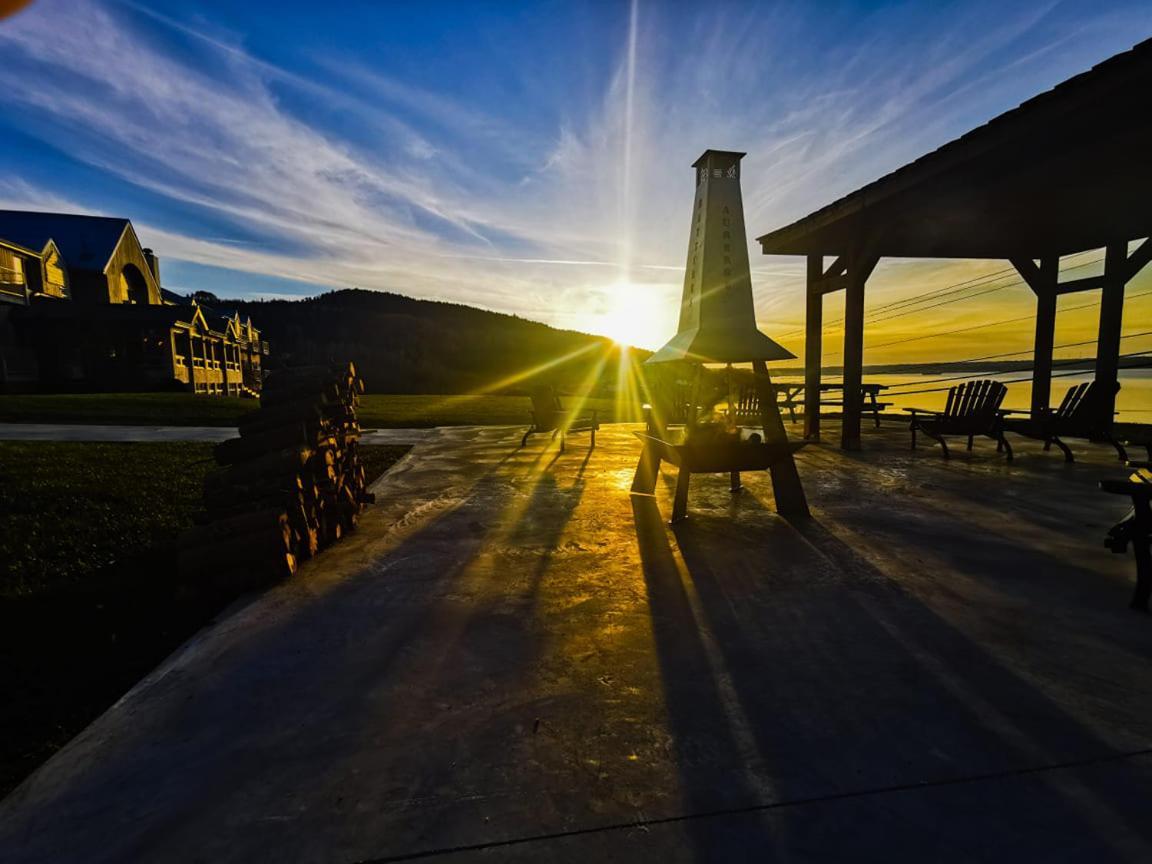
[180,363,373,586]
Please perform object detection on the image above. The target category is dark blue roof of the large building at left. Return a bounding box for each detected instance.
[0,210,131,272]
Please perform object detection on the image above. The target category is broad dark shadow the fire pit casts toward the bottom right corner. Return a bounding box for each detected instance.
[675,499,1152,859]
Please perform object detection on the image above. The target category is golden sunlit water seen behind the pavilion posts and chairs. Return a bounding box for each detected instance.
[772,369,1152,423]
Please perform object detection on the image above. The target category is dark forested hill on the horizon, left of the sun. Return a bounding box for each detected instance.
[219,289,650,394]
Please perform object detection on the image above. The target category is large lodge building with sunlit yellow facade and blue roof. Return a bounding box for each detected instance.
[0,211,268,395]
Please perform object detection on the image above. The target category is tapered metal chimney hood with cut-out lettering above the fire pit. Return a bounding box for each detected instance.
[646,150,796,363]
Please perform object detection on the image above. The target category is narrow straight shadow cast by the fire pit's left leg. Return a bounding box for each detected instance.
[631,495,770,861]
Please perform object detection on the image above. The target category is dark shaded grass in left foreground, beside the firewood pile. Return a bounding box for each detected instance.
[0,441,408,796]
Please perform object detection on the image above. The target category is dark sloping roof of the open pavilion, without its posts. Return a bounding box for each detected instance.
[757,39,1152,258]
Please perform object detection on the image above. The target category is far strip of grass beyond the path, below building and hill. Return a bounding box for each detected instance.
[0,393,639,429]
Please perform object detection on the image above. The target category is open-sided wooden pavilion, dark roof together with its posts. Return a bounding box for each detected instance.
[759,39,1152,449]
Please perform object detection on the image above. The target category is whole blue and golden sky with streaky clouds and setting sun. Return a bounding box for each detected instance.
[0,0,1152,363]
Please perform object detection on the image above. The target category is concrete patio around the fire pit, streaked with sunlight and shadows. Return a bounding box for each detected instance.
[0,426,1152,864]
